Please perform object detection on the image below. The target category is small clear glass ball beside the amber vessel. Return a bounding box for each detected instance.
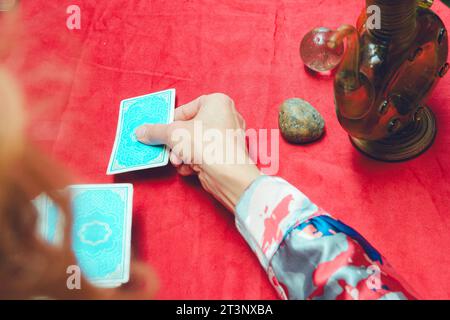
[300,27,344,72]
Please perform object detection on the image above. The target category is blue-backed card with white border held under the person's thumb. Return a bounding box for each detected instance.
[106,89,175,175]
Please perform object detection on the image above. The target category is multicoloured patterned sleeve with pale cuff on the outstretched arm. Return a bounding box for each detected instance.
[236,176,415,300]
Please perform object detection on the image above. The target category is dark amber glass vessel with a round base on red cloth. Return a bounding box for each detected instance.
[329,0,449,161]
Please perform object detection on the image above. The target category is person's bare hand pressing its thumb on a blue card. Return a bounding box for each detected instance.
[137,93,260,211]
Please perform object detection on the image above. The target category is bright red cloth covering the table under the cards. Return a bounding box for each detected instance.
[14,0,450,299]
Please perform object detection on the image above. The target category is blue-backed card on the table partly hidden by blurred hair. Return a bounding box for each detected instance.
[35,184,133,287]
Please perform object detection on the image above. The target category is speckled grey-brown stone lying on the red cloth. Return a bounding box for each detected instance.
[278,98,325,144]
